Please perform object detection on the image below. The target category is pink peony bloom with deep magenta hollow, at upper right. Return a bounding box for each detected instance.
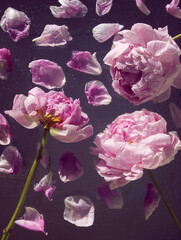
[104,23,181,105]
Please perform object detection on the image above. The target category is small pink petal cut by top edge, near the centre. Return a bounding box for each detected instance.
[96,0,113,16]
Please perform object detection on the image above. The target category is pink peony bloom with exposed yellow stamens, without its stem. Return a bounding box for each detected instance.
[5,87,93,142]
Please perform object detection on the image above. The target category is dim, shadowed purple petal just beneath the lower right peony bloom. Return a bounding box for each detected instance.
[97,183,123,209]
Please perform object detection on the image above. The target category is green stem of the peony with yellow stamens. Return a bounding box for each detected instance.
[1,128,49,240]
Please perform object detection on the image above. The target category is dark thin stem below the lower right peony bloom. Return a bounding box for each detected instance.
[145,169,181,232]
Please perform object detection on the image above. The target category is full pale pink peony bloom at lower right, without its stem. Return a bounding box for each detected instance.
[92,109,181,189]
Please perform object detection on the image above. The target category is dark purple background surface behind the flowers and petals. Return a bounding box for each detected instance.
[0,0,181,240]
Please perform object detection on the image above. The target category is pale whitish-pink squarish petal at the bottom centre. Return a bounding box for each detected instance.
[63,195,95,227]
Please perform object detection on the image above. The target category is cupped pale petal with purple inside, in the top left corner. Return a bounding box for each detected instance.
[0,7,31,42]
